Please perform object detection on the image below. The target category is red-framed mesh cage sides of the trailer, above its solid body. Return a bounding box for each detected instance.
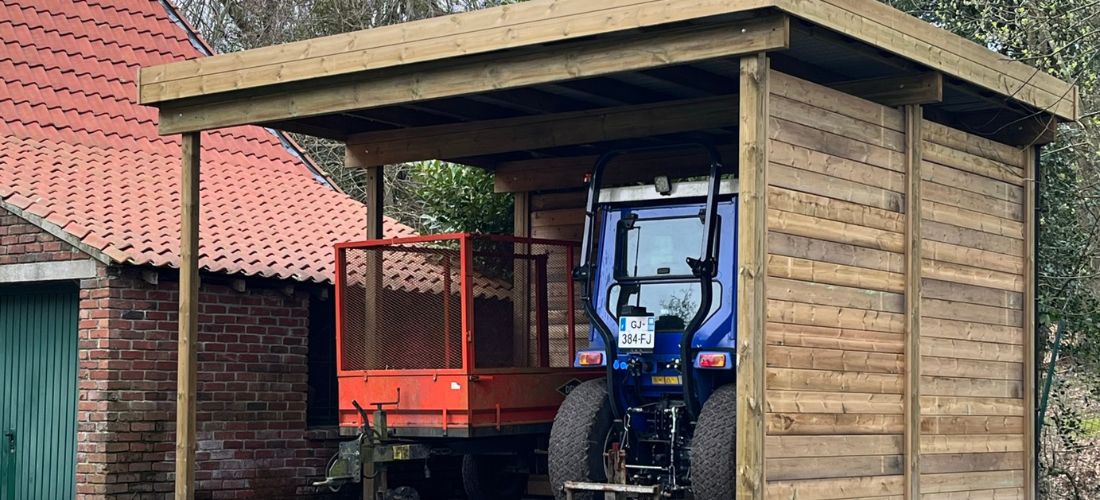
[338,235,589,370]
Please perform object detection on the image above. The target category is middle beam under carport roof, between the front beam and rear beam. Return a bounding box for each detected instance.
[348,96,738,167]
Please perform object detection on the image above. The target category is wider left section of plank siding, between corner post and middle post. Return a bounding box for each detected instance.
[766,71,906,499]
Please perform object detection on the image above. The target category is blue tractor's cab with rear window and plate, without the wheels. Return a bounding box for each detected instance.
[576,184,737,403]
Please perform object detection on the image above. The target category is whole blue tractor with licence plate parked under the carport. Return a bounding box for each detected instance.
[549,145,737,500]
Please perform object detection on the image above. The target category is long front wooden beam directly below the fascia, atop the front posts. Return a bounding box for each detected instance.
[160,13,790,134]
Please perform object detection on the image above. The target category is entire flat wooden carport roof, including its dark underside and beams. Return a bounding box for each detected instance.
[139,0,1080,169]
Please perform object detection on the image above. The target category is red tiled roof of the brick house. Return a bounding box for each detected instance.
[0,0,413,281]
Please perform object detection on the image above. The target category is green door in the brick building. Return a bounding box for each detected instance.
[0,285,78,500]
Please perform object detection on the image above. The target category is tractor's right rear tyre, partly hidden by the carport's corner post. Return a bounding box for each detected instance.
[691,384,737,500]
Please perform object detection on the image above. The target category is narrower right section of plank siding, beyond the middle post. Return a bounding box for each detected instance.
[920,122,1030,499]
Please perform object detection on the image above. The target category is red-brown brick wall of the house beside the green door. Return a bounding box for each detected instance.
[0,209,337,500]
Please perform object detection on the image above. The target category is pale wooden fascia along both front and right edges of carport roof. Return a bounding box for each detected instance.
[140,0,1080,124]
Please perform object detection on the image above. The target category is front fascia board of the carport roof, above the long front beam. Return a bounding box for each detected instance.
[139,0,773,104]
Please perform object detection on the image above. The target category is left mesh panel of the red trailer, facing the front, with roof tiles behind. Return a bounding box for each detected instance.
[341,240,462,370]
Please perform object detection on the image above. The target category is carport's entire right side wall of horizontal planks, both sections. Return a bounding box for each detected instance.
[766,71,1027,499]
